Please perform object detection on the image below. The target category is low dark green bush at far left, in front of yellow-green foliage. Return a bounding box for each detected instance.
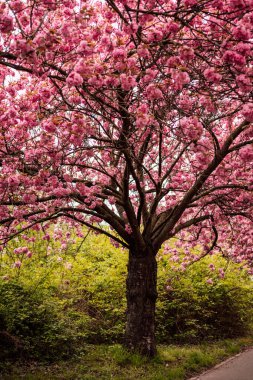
[0,281,85,360]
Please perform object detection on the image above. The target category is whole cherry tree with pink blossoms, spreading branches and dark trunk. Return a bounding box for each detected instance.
[0,0,253,356]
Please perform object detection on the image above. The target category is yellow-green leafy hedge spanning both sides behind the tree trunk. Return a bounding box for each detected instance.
[0,229,253,359]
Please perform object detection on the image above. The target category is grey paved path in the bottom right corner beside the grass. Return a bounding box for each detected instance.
[190,348,253,380]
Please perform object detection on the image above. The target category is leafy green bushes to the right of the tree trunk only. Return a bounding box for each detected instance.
[157,256,253,342]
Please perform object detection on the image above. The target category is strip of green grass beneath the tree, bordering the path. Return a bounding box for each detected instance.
[0,337,253,380]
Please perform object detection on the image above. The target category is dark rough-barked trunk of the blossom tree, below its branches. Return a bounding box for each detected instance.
[125,250,157,357]
